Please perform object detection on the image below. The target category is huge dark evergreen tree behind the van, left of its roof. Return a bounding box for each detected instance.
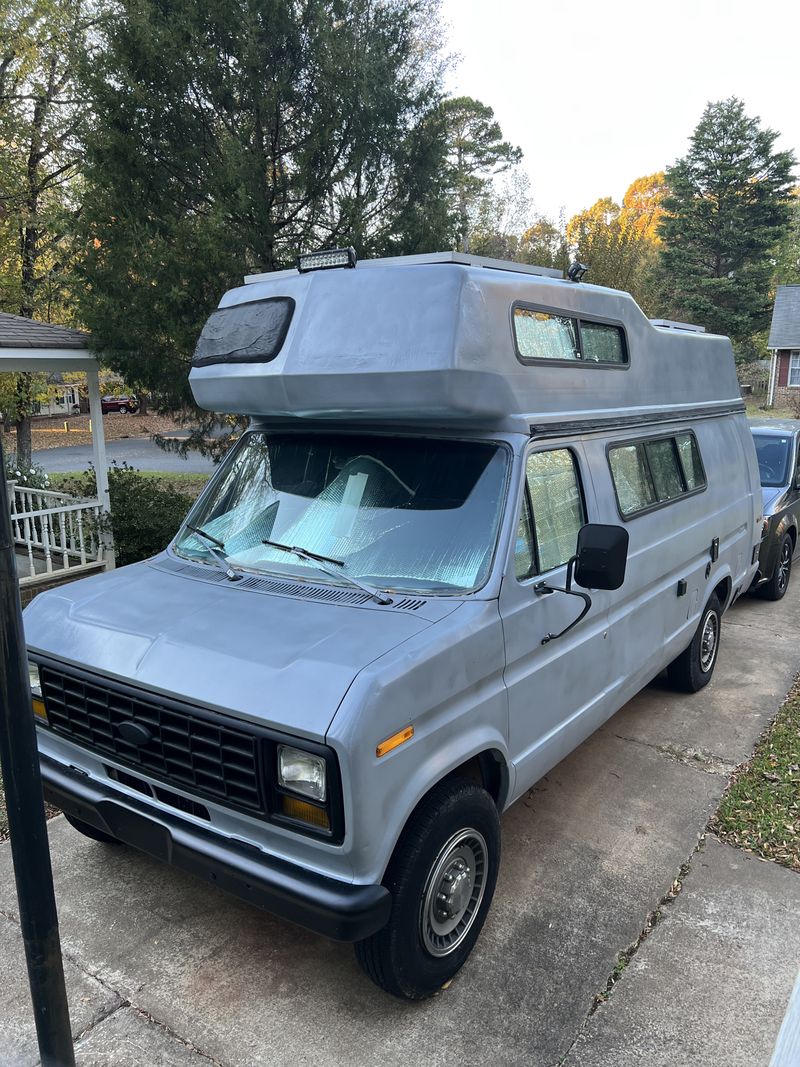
[81,0,456,446]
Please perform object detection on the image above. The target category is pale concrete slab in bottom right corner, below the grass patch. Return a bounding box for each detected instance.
[564,838,800,1067]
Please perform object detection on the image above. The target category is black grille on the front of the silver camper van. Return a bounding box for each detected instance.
[39,665,265,812]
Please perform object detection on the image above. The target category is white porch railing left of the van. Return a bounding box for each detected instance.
[11,485,113,584]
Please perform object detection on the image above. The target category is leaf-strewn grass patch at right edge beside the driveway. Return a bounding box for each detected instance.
[711,680,800,871]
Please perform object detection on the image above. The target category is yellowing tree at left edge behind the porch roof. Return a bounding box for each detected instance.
[0,0,94,467]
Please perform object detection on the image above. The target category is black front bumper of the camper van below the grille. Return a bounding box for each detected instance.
[41,755,391,941]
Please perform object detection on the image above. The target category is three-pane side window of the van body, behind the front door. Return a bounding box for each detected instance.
[608,432,706,519]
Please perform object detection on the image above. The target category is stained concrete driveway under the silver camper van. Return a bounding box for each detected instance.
[0,588,800,1067]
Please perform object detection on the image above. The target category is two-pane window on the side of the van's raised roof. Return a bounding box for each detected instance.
[514,307,628,367]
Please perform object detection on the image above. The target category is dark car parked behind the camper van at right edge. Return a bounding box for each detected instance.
[750,419,800,600]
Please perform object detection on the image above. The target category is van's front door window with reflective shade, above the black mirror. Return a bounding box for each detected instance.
[525,448,586,573]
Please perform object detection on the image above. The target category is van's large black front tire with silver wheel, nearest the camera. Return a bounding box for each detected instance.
[355,779,500,1000]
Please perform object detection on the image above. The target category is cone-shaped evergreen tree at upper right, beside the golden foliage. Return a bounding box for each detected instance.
[659,97,795,339]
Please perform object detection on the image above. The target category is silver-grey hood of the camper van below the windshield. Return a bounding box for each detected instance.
[23,562,445,740]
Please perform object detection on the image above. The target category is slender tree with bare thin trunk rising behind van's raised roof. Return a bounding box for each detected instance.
[442,96,523,252]
